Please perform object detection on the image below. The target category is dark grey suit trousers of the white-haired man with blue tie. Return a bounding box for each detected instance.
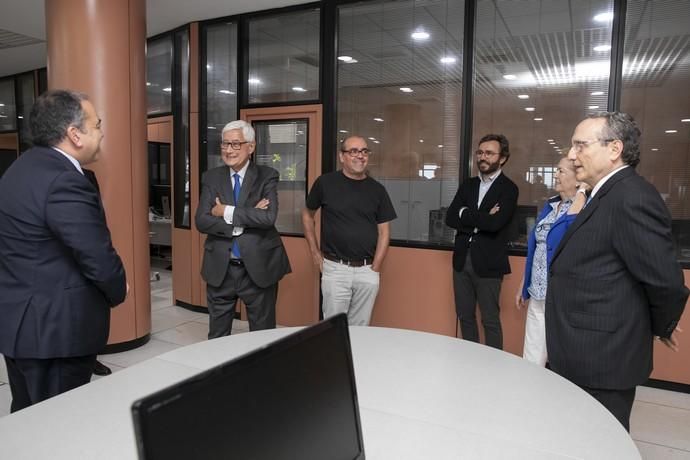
[206,264,278,340]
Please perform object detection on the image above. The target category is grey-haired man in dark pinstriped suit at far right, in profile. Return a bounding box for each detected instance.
[546,112,688,431]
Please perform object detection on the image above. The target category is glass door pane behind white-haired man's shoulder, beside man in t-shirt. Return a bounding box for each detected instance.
[253,120,309,235]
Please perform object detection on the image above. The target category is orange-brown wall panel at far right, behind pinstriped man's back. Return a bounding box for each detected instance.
[652,270,690,385]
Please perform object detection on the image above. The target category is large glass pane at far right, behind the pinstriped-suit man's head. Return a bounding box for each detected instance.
[621,0,690,263]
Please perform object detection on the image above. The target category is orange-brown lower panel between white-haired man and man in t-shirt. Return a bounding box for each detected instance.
[276,236,319,326]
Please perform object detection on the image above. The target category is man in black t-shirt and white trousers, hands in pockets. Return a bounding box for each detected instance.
[302,136,397,326]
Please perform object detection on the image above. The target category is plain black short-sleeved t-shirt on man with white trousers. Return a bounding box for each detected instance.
[306,171,397,260]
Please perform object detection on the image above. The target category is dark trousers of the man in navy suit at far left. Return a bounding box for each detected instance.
[5,355,96,412]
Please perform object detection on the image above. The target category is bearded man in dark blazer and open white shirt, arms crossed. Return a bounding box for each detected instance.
[446,134,518,349]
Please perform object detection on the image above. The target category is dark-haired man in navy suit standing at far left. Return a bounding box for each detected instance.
[0,90,128,412]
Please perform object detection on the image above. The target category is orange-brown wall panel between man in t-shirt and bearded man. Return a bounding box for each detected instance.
[371,247,456,336]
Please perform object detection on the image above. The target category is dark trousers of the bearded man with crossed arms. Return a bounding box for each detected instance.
[453,252,503,350]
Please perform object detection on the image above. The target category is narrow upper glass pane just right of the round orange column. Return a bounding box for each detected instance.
[146,35,173,115]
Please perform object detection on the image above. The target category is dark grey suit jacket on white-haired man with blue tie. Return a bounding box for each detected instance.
[196,163,290,288]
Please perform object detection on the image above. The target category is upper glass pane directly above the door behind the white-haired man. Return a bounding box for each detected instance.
[247,8,320,104]
